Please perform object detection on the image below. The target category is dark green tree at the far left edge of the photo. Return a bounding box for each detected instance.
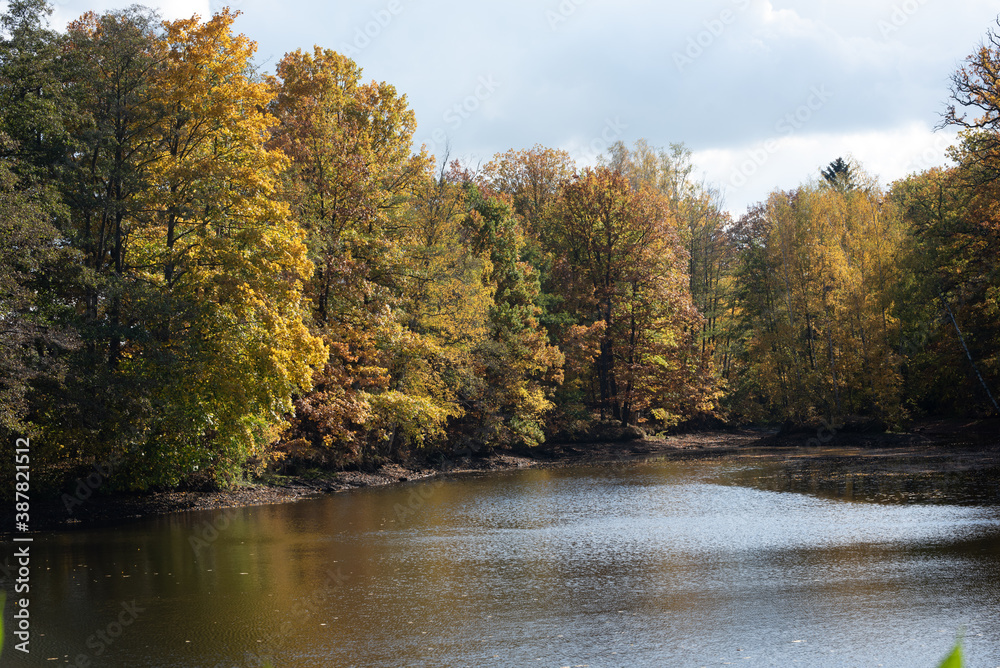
[0,0,77,448]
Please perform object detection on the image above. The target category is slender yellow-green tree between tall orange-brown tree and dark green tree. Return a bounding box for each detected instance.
[369,166,493,460]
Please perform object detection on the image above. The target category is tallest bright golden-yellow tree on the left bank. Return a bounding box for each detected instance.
[59,11,325,486]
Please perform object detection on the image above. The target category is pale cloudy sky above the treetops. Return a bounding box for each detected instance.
[13,0,1000,215]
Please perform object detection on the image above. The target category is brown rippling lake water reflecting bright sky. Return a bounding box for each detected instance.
[3,461,1000,668]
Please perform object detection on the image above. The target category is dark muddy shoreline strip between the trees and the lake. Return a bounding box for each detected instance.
[9,419,1000,534]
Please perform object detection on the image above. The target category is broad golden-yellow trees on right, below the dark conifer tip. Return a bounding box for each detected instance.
[729,174,905,422]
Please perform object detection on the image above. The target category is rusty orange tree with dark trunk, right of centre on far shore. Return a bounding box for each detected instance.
[550,167,711,424]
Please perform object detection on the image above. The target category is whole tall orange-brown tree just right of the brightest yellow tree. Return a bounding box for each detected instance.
[270,47,454,458]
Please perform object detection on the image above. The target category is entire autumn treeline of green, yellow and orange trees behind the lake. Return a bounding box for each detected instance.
[0,0,1000,489]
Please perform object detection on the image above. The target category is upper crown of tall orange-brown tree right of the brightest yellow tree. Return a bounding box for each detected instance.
[270,47,428,326]
